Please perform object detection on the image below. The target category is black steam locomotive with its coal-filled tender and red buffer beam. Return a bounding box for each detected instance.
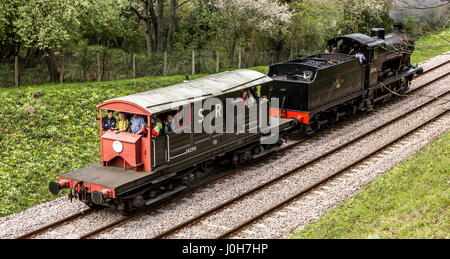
[262,24,423,133]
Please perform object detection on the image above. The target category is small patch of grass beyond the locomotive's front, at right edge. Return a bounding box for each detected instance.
[411,27,450,65]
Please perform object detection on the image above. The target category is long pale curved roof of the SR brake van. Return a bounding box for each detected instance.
[97,69,272,114]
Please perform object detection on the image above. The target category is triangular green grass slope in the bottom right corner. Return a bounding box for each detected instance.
[293,132,450,241]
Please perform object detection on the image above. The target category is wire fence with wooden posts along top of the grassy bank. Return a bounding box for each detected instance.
[0,49,292,86]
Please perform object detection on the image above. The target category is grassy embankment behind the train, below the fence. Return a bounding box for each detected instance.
[0,26,444,216]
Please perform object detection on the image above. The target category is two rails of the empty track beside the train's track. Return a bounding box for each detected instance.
[154,85,450,238]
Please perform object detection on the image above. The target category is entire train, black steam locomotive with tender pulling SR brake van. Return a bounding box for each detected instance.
[49,24,423,214]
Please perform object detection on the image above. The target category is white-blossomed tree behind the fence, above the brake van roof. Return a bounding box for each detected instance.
[210,0,292,66]
